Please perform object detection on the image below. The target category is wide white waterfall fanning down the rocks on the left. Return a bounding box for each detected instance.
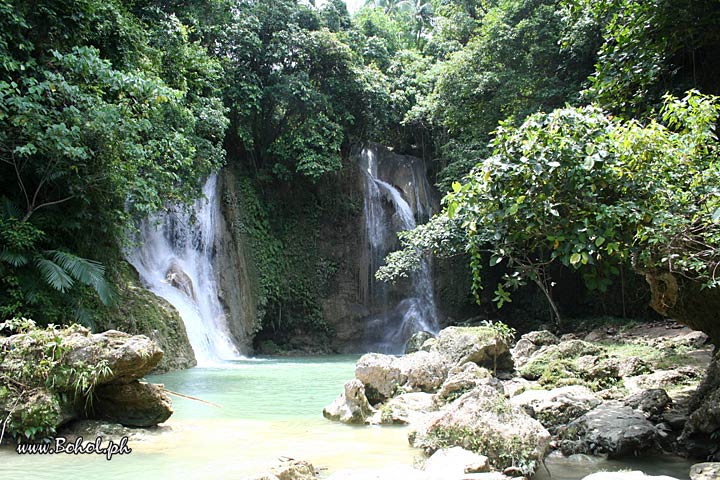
[128,175,240,366]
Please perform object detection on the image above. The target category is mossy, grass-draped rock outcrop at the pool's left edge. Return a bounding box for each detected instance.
[0,320,172,442]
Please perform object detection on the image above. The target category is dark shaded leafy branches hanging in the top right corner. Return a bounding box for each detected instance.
[567,0,720,116]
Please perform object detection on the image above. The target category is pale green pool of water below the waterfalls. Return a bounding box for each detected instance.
[0,356,689,480]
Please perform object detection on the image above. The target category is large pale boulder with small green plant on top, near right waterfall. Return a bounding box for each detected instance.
[433,327,514,371]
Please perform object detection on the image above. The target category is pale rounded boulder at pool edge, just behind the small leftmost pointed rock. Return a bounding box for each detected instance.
[355,353,407,404]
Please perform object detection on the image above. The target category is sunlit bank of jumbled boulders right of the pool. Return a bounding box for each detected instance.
[316,323,720,479]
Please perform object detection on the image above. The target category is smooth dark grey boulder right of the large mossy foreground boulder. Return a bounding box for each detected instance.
[558,402,660,457]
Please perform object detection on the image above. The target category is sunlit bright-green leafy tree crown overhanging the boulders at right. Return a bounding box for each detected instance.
[447,93,720,322]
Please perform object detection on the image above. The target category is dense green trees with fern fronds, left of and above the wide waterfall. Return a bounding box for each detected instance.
[0,0,227,323]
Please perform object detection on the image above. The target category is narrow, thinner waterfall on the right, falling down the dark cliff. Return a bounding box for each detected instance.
[360,147,439,353]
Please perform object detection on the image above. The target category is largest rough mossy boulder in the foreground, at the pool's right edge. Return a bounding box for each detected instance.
[408,385,550,473]
